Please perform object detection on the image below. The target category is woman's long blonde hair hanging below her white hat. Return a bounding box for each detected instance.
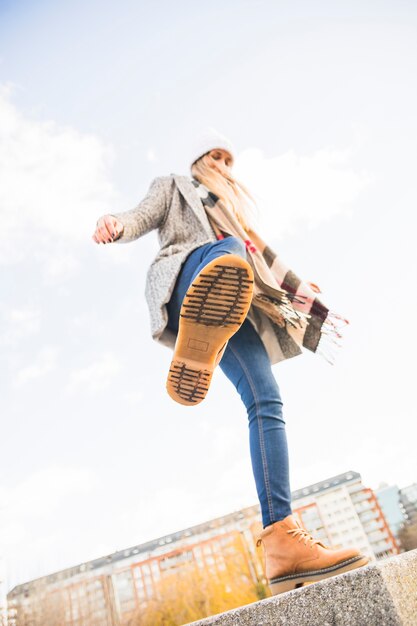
[191,152,257,231]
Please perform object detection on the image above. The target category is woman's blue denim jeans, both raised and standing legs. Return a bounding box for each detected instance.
[168,237,292,528]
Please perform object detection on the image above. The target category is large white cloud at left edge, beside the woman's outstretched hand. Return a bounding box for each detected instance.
[0,84,120,266]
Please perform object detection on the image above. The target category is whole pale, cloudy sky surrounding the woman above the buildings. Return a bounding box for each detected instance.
[0,0,417,588]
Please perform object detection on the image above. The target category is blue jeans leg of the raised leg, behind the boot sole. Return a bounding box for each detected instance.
[167,237,246,332]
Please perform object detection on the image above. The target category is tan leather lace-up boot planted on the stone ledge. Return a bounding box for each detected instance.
[256,515,369,595]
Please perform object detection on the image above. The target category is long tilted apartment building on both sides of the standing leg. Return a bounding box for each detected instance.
[8,471,399,626]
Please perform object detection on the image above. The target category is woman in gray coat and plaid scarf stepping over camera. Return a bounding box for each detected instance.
[93,128,368,594]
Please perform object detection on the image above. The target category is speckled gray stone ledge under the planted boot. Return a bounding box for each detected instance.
[184,550,417,626]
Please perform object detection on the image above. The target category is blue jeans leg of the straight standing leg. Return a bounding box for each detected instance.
[219,319,292,528]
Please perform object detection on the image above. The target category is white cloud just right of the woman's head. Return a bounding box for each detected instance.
[235,139,374,237]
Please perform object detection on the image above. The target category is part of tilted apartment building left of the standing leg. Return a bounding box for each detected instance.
[8,506,263,626]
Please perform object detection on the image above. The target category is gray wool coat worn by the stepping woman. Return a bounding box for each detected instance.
[111,174,275,361]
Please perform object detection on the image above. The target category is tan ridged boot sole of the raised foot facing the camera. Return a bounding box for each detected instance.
[166,254,254,406]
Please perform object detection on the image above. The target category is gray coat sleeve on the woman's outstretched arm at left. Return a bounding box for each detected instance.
[110,176,167,243]
